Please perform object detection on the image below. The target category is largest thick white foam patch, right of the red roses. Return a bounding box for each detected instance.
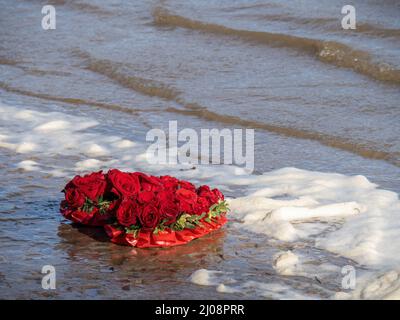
[230,168,400,265]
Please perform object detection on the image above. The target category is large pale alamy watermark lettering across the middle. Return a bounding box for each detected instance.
[146,121,254,172]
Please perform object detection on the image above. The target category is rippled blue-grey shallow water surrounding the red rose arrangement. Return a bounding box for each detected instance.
[0,0,400,299]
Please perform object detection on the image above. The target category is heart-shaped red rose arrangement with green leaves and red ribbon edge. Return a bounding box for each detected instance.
[60,169,229,248]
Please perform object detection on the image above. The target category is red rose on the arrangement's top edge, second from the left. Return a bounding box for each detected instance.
[107,169,140,197]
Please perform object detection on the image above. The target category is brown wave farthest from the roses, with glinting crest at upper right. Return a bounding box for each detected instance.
[153,8,400,84]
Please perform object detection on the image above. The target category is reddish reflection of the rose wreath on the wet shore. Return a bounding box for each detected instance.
[56,224,234,299]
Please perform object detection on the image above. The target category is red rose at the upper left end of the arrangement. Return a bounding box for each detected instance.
[66,171,107,201]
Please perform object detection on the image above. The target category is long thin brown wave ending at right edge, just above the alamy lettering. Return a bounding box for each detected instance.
[53,50,400,166]
